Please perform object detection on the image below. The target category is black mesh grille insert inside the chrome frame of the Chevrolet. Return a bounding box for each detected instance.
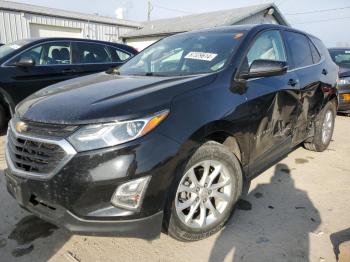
[8,131,66,174]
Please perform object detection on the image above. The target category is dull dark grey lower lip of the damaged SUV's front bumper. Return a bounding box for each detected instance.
[5,171,163,239]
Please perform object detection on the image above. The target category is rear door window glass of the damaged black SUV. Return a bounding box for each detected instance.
[286,31,313,68]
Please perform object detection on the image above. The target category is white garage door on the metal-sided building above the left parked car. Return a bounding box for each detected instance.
[29,24,82,38]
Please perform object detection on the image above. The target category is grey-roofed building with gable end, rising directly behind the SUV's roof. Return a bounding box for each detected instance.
[122,4,289,51]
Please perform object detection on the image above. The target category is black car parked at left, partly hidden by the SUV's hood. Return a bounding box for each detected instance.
[0,38,137,129]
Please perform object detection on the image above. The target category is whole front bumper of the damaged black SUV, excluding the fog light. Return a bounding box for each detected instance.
[5,133,179,239]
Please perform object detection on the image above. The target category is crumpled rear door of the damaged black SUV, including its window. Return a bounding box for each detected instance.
[285,31,328,145]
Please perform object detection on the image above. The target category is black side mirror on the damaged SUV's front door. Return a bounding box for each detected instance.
[241,59,288,79]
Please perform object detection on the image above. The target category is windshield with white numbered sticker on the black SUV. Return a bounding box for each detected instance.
[119,31,243,76]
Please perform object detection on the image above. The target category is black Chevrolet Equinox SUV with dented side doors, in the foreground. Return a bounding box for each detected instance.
[4,25,338,241]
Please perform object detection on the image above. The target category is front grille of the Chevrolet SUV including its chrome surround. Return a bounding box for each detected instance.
[6,120,76,179]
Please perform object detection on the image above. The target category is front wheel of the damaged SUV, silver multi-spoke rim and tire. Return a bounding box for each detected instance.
[165,142,243,241]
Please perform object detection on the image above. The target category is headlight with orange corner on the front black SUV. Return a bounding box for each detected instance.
[68,110,169,152]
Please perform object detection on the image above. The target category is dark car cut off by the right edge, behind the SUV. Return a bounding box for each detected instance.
[329,48,350,116]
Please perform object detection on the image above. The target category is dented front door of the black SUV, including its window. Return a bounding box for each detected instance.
[241,30,300,175]
